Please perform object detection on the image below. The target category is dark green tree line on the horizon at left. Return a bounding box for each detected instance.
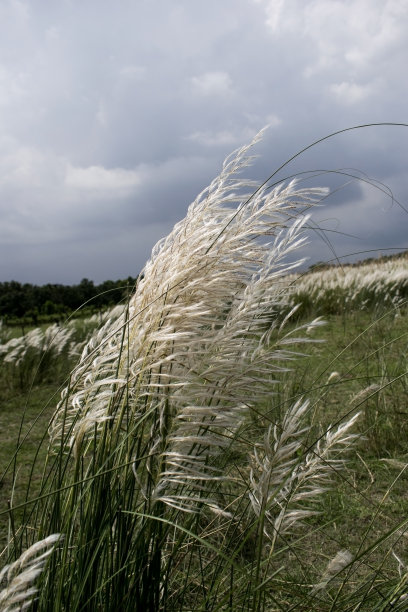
[0,276,137,325]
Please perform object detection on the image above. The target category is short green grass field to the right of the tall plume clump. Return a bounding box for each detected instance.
[255,311,408,610]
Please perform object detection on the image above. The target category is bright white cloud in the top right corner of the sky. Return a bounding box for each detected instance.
[262,0,408,80]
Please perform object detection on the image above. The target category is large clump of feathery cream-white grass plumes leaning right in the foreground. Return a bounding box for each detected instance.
[50,128,327,511]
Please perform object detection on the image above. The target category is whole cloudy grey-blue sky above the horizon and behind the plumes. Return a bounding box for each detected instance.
[0,0,408,284]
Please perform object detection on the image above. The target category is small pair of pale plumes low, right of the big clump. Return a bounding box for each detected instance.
[249,401,359,545]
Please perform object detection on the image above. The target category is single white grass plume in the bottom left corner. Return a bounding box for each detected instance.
[0,534,61,612]
